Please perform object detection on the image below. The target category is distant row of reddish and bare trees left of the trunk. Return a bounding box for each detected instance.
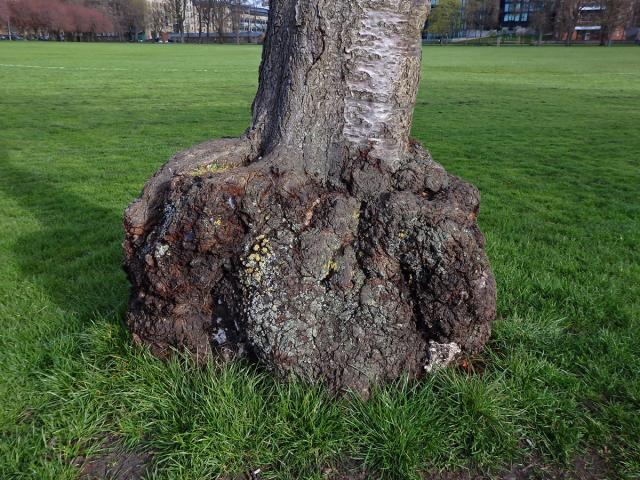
[0,0,268,41]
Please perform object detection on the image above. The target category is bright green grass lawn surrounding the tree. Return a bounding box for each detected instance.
[0,42,640,479]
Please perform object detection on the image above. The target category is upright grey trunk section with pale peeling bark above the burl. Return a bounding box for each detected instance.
[250,0,427,181]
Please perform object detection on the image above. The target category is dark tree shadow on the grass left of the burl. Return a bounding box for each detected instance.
[0,157,128,322]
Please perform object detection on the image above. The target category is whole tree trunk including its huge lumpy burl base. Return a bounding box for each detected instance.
[124,0,496,396]
